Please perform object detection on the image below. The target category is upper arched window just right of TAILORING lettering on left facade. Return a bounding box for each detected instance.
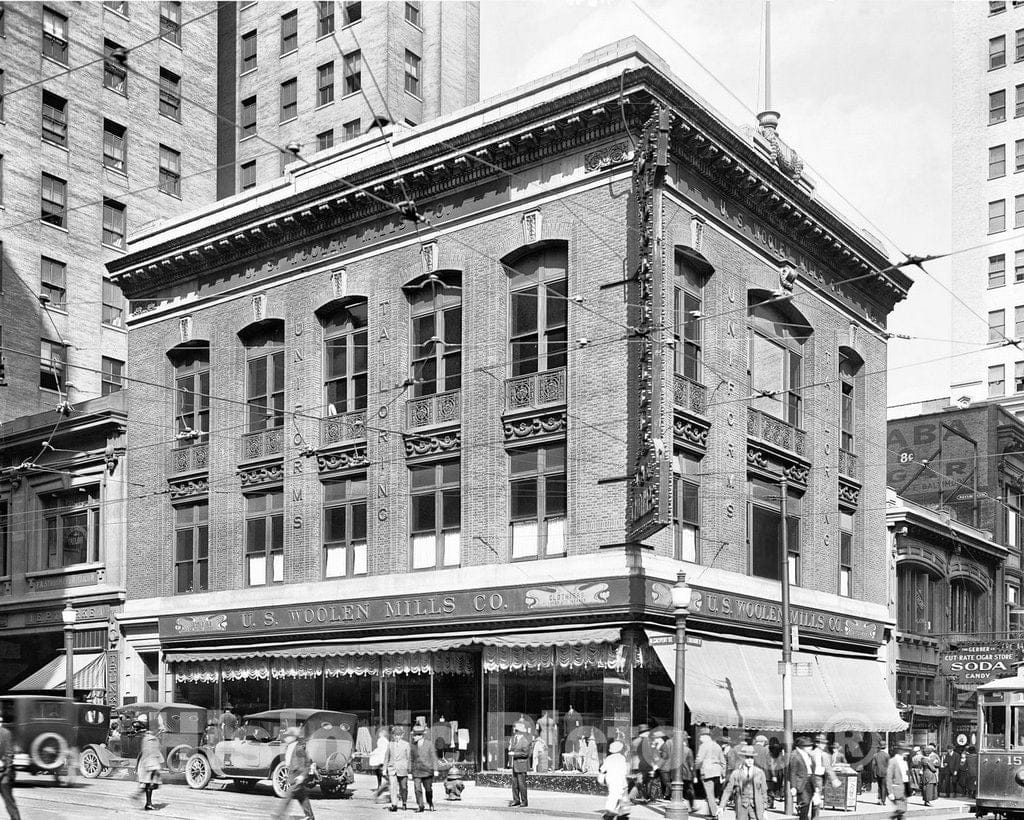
[410,271,462,396]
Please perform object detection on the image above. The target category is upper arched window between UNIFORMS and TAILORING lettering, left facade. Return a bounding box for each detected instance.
[324,301,369,416]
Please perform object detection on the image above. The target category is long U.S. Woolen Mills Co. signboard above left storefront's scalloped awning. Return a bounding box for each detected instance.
[160,578,629,641]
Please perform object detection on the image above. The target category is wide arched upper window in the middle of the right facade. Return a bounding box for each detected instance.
[749,291,811,427]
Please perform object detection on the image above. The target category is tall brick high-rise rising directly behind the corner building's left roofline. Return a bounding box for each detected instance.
[217,0,480,197]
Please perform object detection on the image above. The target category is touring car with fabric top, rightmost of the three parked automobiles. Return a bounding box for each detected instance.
[185,708,356,797]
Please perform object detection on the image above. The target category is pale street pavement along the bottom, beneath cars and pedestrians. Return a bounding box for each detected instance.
[4,775,971,820]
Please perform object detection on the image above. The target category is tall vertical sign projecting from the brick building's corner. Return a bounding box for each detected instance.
[626,106,672,542]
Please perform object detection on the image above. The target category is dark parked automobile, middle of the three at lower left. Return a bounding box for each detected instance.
[78,702,206,779]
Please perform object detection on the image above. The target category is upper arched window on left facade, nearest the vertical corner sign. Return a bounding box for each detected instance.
[505,244,568,376]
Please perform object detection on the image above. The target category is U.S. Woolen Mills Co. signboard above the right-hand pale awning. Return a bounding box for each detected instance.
[648,581,885,643]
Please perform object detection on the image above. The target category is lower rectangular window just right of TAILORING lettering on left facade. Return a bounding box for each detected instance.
[409,461,462,569]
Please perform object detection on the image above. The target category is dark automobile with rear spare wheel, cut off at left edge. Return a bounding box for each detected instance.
[0,695,111,776]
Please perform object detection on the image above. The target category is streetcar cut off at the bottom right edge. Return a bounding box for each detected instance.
[975,665,1024,820]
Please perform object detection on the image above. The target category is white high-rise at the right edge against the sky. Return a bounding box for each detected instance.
[949,2,1024,413]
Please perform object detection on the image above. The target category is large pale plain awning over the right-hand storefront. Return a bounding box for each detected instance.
[653,640,906,732]
